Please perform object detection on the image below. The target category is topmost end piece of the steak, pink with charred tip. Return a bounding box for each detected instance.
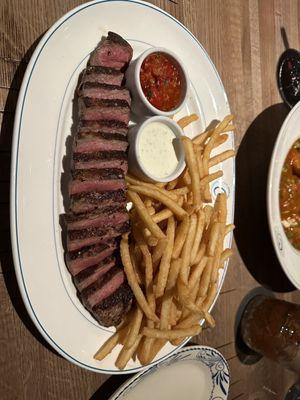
[89,32,133,70]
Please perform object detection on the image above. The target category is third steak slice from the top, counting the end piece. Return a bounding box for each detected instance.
[78,82,131,106]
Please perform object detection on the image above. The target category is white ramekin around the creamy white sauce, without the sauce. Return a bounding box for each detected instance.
[128,116,185,182]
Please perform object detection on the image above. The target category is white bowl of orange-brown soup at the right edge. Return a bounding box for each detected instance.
[267,102,300,289]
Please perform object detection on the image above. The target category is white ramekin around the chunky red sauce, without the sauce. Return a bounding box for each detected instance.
[126,47,189,116]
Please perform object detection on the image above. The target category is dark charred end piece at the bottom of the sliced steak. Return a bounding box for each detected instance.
[92,282,133,326]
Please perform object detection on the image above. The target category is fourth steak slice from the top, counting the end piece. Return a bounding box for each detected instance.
[79,97,130,125]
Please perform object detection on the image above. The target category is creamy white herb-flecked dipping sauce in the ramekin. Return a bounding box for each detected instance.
[138,122,179,178]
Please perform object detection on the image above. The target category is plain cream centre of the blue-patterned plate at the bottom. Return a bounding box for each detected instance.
[122,360,213,400]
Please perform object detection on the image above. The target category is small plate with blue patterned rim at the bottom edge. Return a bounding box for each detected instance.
[109,346,230,400]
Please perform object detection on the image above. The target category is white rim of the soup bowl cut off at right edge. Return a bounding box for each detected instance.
[267,102,300,289]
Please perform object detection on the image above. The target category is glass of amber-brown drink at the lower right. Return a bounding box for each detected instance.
[241,295,300,374]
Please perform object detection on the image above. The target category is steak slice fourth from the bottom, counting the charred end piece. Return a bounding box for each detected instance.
[66,241,117,276]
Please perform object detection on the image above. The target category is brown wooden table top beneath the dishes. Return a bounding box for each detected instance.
[0,0,300,400]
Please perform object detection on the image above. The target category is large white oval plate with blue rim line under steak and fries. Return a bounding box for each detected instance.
[11,0,234,374]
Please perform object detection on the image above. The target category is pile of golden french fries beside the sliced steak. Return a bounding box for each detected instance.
[94,114,234,369]
